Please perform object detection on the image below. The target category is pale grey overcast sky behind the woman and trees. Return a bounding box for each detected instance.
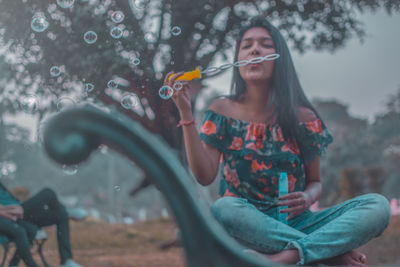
[207,11,400,121]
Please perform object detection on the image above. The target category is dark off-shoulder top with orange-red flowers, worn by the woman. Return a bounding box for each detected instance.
[200,110,333,211]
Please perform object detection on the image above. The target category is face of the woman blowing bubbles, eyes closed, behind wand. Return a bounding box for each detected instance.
[238,27,275,82]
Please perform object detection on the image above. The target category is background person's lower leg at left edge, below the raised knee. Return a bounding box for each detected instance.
[0,218,38,267]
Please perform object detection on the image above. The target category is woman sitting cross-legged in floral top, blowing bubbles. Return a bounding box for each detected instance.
[165,17,390,266]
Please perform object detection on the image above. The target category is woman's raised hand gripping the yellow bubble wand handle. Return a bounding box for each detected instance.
[164,72,192,117]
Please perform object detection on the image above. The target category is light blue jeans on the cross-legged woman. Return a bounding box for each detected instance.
[211,194,390,265]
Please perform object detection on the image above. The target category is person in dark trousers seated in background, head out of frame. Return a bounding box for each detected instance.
[0,182,81,267]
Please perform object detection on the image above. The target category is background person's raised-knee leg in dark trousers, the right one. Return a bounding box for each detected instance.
[21,188,79,266]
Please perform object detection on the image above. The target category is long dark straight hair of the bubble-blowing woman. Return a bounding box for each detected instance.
[230,16,320,144]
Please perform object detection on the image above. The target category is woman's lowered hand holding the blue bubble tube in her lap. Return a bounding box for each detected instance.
[278,191,312,220]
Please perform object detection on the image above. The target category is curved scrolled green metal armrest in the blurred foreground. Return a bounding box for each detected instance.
[44,105,283,267]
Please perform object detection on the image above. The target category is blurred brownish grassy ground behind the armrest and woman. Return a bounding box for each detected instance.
[3,216,400,267]
